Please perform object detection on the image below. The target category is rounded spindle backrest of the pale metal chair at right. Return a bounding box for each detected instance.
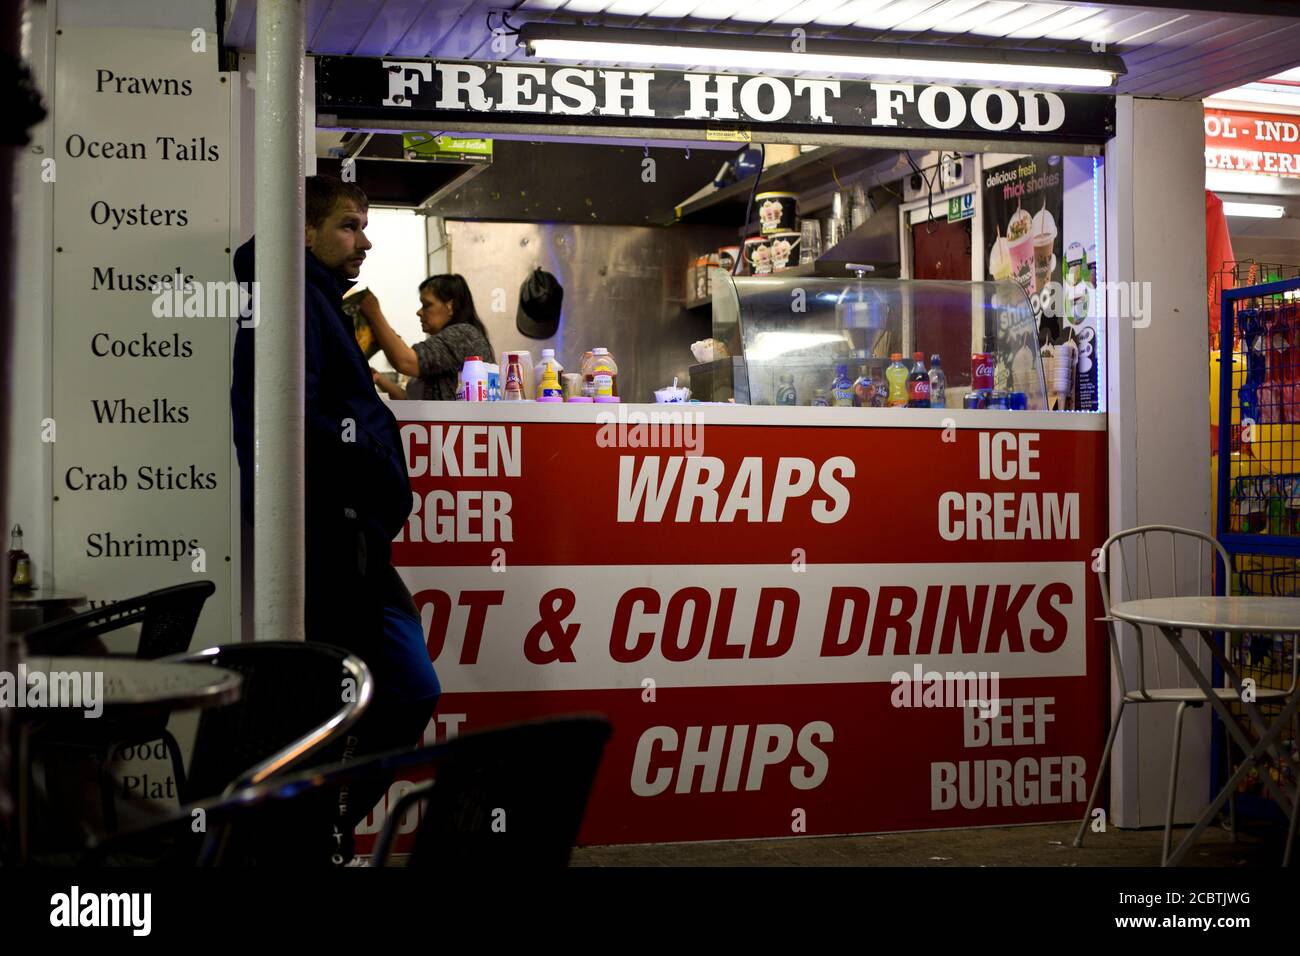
[1097,524,1232,693]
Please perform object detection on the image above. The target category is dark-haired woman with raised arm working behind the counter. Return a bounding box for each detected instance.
[361,274,493,402]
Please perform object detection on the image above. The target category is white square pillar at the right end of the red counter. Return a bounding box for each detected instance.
[1104,96,1210,827]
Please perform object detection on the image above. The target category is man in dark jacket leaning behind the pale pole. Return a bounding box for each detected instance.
[230,176,441,864]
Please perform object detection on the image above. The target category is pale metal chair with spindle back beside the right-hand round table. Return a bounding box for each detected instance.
[1074,524,1295,865]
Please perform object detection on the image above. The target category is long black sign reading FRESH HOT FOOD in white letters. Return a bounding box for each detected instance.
[316,56,1115,143]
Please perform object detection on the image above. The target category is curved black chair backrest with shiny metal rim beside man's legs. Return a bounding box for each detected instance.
[173,641,374,803]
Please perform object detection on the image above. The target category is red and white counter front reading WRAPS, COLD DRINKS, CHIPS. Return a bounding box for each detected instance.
[360,410,1106,843]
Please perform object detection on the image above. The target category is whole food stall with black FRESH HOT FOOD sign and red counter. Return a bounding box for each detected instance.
[316,57,1113,843]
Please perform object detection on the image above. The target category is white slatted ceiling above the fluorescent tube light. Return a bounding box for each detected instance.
[226,0,1300,98]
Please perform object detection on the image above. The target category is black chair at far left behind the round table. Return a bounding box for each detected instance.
[22,581,217,831]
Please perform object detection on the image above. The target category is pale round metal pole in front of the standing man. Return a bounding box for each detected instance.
[254,0,304,640]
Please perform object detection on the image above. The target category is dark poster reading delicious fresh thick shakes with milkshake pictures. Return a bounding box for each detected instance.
[983,156,1065,342]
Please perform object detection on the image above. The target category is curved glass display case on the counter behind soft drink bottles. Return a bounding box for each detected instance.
[692,272,1048,410]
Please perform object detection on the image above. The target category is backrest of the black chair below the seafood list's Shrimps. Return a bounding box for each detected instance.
[22,581,217,661]
